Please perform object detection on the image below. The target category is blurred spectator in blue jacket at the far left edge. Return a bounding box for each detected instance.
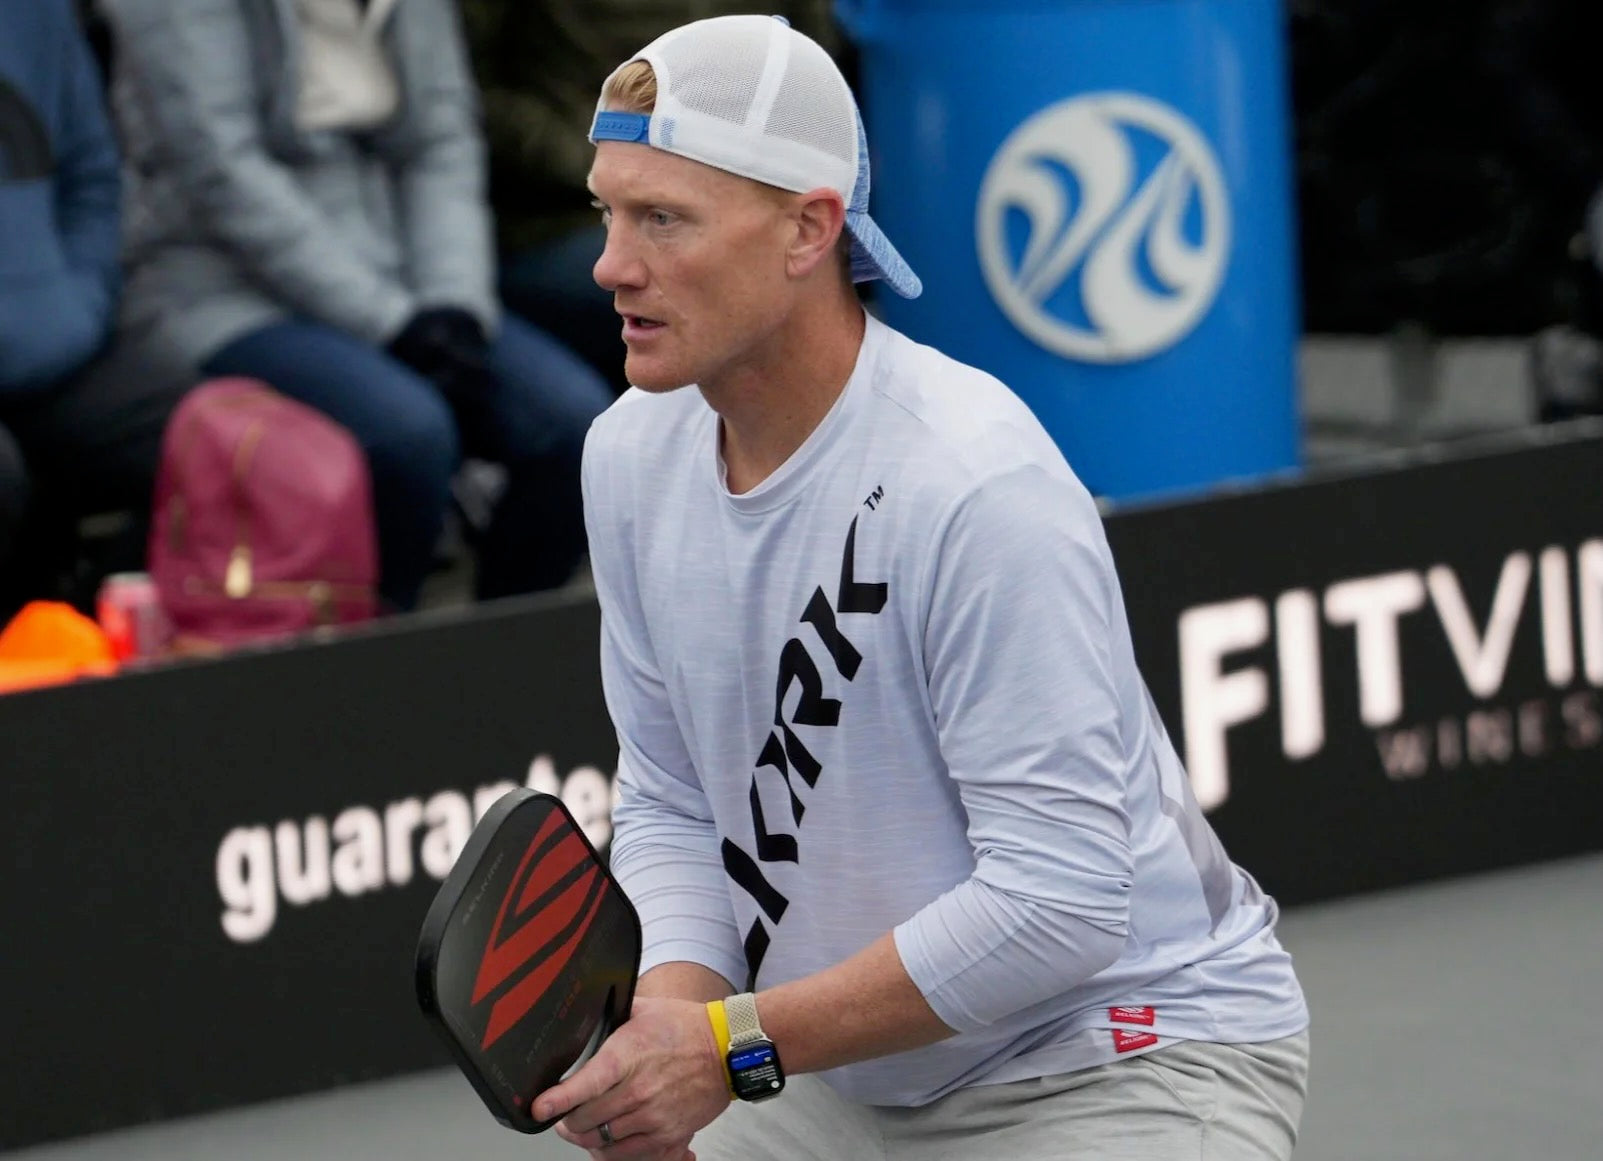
[0,0,188,619]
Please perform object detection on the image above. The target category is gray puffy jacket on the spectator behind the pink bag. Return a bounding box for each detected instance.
[101,0,499,366]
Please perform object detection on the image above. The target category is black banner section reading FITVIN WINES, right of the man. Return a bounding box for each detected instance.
[1108,422,1603,903]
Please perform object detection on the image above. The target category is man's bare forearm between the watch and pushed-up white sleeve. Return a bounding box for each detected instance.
[750,935,955,1073]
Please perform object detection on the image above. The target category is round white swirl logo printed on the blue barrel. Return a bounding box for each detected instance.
[975,93,1231,362]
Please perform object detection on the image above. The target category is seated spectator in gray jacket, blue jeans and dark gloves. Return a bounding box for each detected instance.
[101,0,611,608]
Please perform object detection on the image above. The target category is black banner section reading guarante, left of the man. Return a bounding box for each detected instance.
[0,600,617,1148]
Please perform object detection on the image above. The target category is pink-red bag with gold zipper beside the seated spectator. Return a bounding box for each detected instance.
[149,378,378,648]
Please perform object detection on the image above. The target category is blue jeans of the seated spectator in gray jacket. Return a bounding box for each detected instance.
[204,316,612,609]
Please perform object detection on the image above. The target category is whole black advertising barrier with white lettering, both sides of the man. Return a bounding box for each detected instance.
[9,425,1603,1150]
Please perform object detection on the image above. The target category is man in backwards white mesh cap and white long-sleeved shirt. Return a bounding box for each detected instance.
[535,16,1308,1161]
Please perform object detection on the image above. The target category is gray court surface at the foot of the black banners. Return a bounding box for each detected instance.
[6,855,1603,1161]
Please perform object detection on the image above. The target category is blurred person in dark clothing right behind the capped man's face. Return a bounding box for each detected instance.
[463,0,850,390]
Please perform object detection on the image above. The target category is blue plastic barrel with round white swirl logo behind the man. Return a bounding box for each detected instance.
[837,0,1300,499]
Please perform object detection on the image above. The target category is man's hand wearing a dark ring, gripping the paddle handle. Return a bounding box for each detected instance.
[534,996,729,1161]
